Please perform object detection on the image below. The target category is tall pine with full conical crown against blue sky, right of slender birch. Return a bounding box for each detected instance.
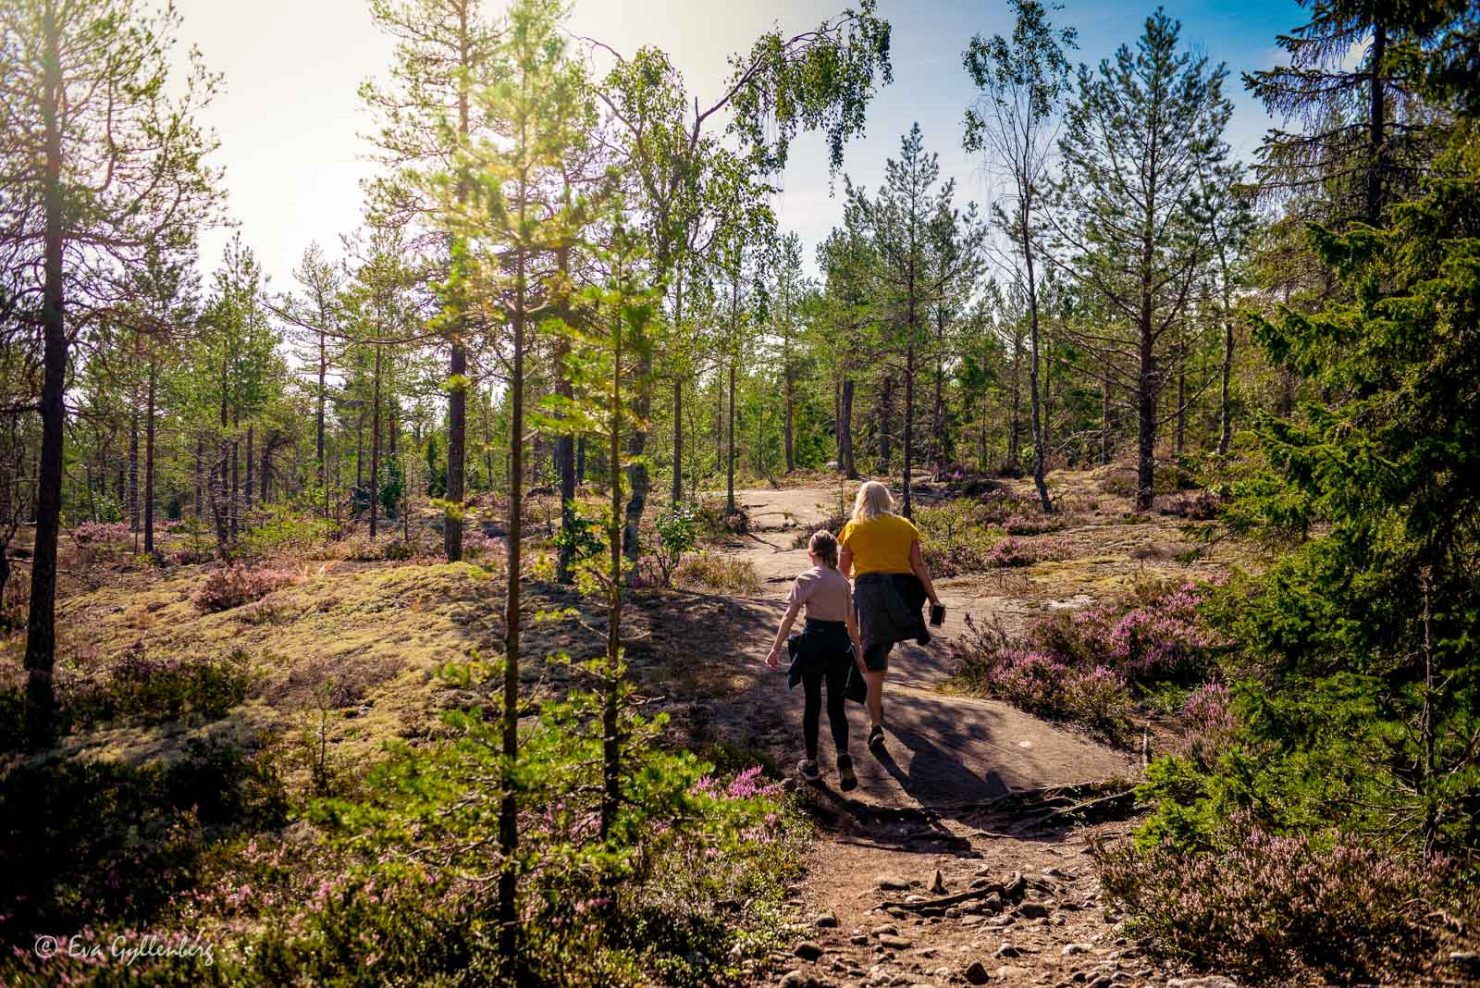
[1054,10,1231,510]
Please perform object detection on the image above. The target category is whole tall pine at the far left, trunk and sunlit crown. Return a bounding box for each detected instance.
[0,0,215,744]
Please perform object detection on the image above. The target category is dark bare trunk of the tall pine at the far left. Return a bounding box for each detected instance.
[25,4,67,739]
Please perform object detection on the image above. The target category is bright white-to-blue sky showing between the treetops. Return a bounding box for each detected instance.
[176,0,1304,290]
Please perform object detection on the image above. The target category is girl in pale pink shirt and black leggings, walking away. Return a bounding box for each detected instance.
[765,531,863,790]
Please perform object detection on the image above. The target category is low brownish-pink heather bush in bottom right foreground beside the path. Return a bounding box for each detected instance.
[1095,813,1437,984]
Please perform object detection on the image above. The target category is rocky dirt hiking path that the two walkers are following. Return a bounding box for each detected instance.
[707,485,1233,988]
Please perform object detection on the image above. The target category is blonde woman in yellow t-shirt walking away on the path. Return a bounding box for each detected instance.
[838,481,941,750]
